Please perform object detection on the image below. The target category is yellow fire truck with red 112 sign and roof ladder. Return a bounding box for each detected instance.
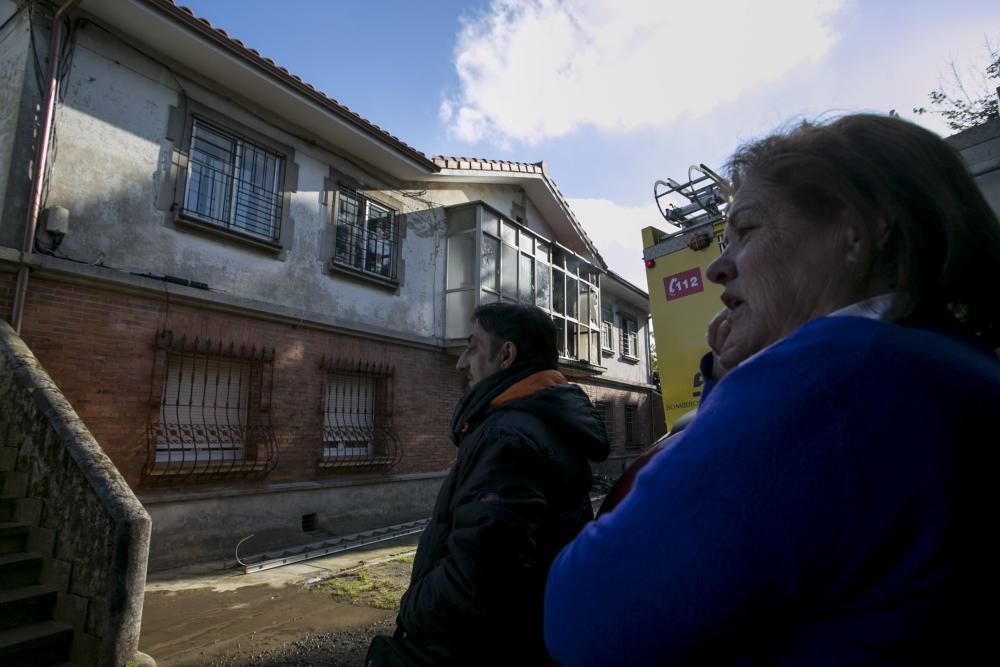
[642,164,729,429]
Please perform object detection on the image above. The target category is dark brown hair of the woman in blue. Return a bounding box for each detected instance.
[729,114,1000,347]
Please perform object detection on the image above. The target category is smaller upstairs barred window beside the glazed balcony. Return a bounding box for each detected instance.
[333,188,399,281]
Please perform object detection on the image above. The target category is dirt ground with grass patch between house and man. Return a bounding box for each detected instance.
[139,536,416,667]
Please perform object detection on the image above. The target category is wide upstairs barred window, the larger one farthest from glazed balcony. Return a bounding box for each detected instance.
[182,118,284,241]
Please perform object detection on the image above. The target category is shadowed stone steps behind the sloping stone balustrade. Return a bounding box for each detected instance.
[0,471,73,667]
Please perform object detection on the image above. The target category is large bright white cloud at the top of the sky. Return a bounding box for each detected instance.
[440,0,849,143]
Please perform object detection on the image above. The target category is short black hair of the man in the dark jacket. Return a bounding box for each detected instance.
[472,302,559,369]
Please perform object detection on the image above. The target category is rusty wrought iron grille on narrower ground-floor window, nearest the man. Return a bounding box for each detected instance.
[319,357,401,470]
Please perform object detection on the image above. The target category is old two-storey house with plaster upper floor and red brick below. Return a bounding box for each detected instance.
[0,0,663,569]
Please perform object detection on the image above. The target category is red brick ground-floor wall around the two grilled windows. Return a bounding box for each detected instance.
[13,274,463,489]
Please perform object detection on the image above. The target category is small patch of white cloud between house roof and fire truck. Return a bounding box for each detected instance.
[568,199,671,290]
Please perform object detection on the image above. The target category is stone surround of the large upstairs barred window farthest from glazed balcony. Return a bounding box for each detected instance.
[157,95,298,259]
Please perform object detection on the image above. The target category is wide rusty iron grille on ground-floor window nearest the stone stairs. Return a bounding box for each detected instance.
[143,331,277,484]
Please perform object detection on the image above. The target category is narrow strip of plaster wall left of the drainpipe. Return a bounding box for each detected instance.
[0,0,34,248]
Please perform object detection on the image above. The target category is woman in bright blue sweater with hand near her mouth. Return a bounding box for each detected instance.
[545,115,1000,666]
